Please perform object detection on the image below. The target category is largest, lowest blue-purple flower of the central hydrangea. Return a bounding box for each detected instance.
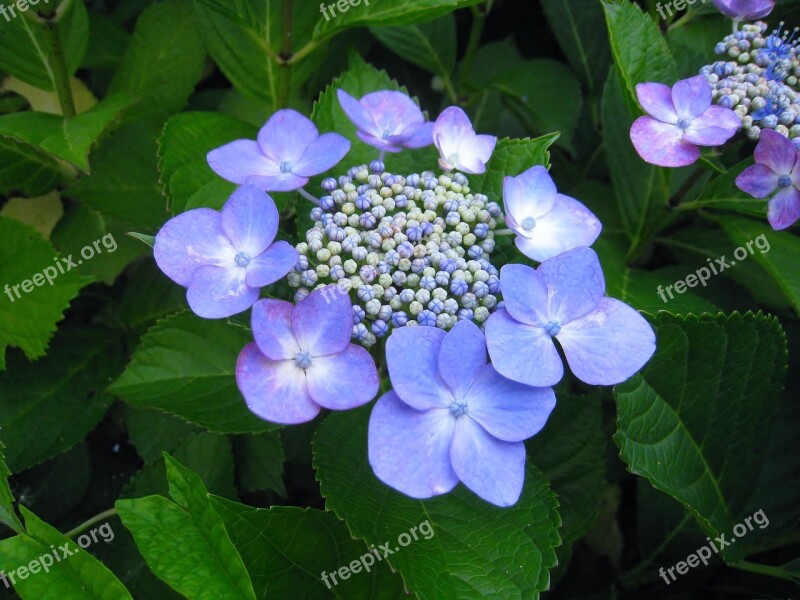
[369,321,555,506]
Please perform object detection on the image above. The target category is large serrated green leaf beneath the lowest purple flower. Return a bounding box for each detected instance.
[314,406,560,600]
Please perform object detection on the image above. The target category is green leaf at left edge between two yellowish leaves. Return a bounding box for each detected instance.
[0,95,130,173]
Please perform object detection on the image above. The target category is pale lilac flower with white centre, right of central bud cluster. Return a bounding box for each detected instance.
[503,166,602,262]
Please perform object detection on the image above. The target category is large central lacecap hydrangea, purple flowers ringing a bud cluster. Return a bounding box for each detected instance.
[155,90,655,506]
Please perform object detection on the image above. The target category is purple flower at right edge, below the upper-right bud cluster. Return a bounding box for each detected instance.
[736,129,800,231]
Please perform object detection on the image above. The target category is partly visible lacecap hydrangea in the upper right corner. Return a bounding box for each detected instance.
[630,0,800,230]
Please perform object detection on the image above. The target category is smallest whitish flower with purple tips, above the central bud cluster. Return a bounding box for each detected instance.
[433,106,497,174]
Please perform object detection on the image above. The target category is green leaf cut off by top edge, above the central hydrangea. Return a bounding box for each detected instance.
[309,0,481,44]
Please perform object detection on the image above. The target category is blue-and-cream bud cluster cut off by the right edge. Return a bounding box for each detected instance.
[700,21,800,148]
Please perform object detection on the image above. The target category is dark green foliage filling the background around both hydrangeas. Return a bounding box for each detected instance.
[0,0,800,598]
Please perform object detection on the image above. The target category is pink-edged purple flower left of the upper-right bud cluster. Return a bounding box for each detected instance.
[631,75,742,167]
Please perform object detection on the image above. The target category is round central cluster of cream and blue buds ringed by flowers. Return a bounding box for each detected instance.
[287,160,503,347]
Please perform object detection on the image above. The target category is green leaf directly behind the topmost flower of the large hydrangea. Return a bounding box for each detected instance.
[311,55,436,173]
